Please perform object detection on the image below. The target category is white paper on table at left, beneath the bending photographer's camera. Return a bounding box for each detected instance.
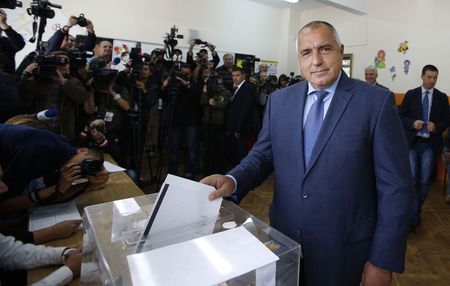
[28,200,81,231]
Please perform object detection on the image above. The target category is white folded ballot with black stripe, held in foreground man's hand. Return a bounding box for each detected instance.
[138,174,222,242]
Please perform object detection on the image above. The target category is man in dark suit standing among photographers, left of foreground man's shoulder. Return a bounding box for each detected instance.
[225,67,257,164]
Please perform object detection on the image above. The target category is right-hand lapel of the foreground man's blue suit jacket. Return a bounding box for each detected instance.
[302,72,353,178]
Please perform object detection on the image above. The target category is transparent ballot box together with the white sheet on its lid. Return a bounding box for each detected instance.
[80,190,301,286]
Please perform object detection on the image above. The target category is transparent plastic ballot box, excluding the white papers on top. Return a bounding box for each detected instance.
[80,194,301,286]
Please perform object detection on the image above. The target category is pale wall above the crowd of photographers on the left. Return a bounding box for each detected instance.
[7,0,288,72]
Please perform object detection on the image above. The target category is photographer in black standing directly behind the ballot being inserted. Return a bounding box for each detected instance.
[162,64,201,179]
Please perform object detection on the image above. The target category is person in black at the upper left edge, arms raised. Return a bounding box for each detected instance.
[0,9,25,74]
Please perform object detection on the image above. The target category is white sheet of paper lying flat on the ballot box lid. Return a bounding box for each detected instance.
[127,227,278,286]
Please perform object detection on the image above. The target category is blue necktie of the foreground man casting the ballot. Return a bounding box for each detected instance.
[303,90,328,166]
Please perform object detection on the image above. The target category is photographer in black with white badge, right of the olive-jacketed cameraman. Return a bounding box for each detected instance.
[89,57,130,166]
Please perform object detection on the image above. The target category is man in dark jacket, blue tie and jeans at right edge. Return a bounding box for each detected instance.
[399,65,450,231]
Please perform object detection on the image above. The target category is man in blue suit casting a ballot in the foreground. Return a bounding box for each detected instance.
[202,21,412,286]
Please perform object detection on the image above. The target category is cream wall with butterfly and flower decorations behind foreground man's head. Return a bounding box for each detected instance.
[298,0,450,93]
